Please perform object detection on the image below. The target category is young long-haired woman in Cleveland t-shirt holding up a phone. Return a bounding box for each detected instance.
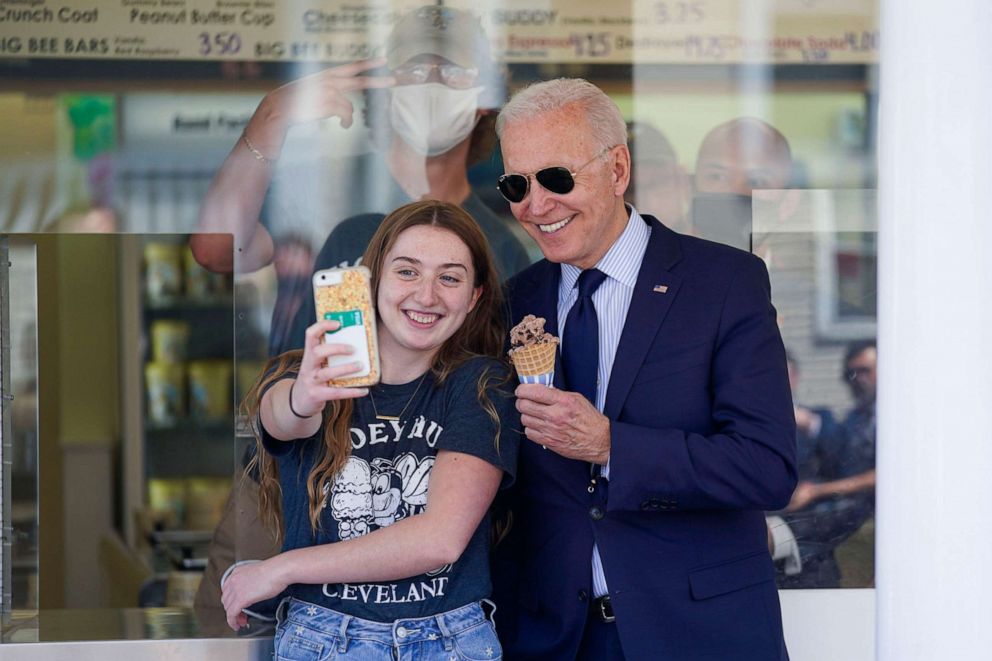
[222,201,520,660]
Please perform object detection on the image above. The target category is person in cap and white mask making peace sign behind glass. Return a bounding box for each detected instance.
[191,6,530,355]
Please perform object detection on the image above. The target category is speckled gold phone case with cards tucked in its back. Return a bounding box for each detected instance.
[313,266,380,387]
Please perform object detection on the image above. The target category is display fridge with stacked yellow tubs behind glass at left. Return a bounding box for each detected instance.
[120,235,235,592]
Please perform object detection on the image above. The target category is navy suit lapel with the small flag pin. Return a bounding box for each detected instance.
[603,216,682,420]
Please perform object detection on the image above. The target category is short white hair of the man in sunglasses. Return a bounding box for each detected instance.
[496,78,627,149]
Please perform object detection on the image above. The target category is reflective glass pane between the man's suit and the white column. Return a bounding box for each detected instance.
[752,189,877,588]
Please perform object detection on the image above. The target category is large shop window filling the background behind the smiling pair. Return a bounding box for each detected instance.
[0,0,878,641]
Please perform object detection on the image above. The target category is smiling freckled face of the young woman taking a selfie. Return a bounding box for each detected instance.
[376,225,482,366]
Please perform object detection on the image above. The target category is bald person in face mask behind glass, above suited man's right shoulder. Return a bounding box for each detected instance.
[692,117,793,250]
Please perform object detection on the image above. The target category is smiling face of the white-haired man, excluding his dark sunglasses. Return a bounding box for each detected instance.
[500,108,630,269]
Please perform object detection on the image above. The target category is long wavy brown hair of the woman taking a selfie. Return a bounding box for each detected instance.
[242,200,505,533]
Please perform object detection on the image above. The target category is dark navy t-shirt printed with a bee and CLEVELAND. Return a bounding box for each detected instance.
[263,357,521,622]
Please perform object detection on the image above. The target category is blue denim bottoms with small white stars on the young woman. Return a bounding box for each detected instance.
[275,597,503,661]
